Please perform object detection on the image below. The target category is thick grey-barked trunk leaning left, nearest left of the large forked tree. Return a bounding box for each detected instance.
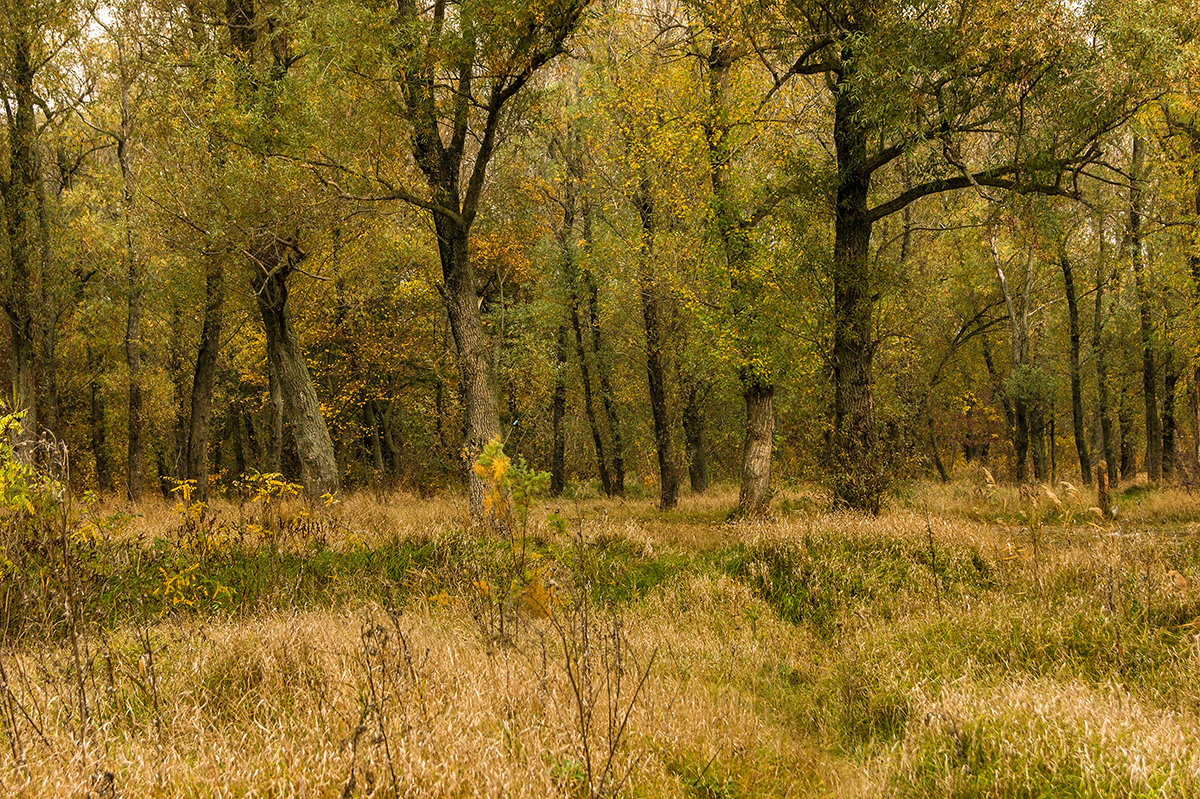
[254,253,338,498]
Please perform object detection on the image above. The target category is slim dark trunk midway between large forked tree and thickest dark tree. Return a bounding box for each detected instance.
[635,178,679,510]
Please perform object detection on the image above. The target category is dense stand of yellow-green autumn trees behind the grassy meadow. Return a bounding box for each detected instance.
[0,0,1200,513]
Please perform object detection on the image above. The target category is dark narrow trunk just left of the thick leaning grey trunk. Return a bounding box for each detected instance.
[187,256,224,501]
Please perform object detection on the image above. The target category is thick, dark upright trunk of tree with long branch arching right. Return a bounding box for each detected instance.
[833,65,888,513]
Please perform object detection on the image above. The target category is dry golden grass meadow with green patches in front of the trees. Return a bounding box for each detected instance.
[0,481,1200,797]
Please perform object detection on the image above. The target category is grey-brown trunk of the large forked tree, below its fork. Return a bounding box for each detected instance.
[434,214,500,521]
